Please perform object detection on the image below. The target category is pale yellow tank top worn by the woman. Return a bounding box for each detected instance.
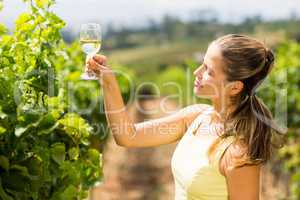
[171,107,234,200]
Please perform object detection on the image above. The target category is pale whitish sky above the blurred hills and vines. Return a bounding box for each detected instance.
[0,0,300,31]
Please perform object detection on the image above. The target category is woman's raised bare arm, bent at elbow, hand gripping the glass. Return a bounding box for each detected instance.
[87,55,208,147]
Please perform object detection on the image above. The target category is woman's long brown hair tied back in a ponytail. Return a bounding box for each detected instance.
[208,34,282,166]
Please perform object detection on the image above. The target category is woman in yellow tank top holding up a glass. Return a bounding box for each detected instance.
[87,34,282,200]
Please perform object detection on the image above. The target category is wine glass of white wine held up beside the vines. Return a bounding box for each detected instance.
[80,23,101,80]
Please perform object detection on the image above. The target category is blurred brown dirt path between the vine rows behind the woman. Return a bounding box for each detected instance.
[90,99,288,200]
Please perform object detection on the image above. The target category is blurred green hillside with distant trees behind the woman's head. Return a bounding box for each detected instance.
[63,10,300,81]
